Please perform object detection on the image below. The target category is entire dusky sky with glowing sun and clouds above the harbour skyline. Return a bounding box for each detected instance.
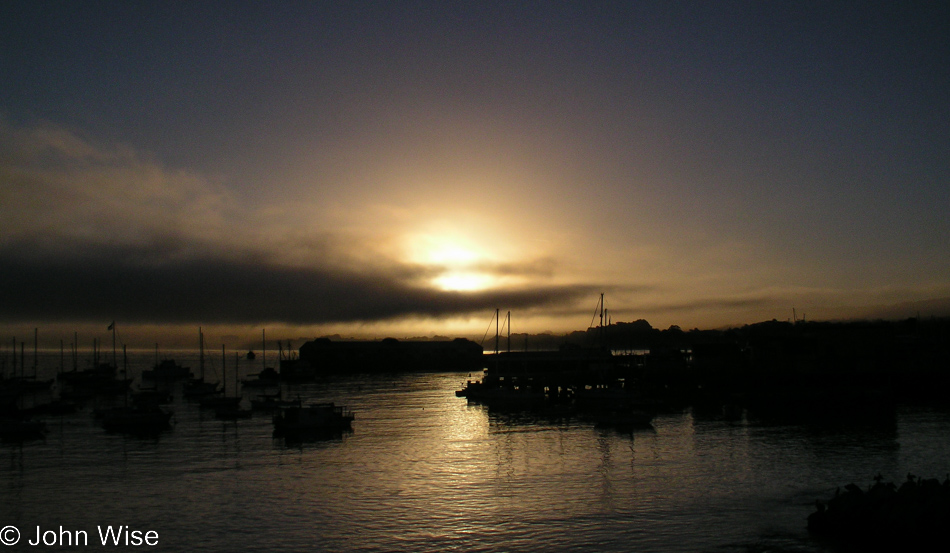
[0,0,950,340]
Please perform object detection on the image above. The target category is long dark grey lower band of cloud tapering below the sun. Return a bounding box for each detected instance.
[0,243,595,324]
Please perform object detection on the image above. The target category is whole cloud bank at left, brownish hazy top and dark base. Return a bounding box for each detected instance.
[0,116,596,324]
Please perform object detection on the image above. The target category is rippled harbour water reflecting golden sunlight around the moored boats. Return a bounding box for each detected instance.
[0,353,950,552]
